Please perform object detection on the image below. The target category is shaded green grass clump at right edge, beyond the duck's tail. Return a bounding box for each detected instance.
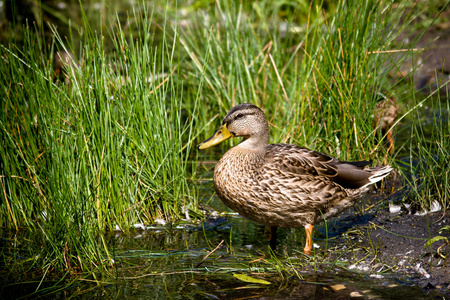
[403,88,450,211]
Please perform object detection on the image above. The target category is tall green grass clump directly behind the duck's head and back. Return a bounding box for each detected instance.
[182,1,410,160]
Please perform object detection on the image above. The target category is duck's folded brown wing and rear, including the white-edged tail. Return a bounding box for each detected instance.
[254,144,391,224]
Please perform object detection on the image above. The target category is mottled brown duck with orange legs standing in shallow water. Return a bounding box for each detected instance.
[198,103,392,255]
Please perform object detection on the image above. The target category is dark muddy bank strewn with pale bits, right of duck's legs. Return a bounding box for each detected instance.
[320,205,450,296]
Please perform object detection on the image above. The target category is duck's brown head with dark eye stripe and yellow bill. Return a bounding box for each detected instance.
[198,103,269,150]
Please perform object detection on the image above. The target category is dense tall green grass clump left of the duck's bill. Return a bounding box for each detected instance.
[0,5,197,271]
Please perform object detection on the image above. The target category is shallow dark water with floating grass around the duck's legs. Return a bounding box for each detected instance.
[2,193,442,299]
